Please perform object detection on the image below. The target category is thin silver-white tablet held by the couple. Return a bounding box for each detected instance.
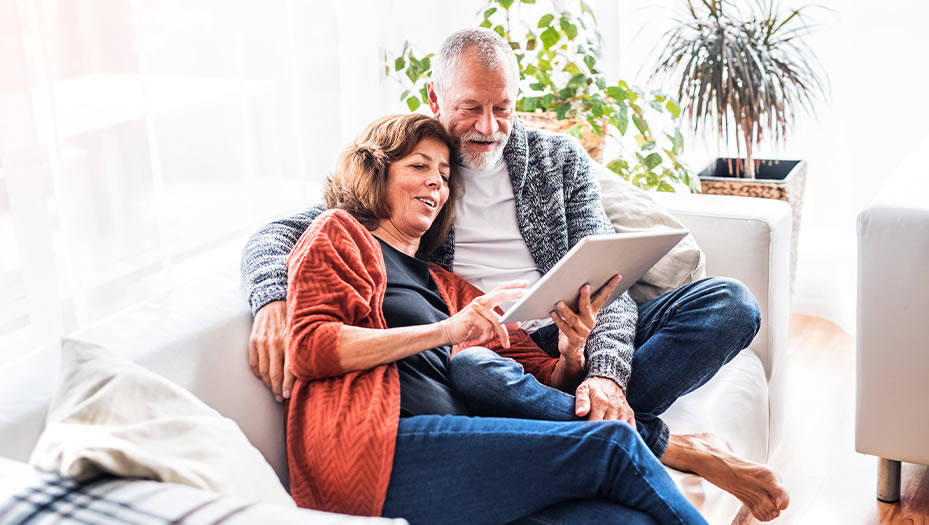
[500,230,687,323]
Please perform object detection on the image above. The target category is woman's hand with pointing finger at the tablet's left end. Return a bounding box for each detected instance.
[440,281,529,348]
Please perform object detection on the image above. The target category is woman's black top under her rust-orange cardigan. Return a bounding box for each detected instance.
[378,239,468,417]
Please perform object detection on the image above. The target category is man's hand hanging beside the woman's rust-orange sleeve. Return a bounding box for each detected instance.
[248,301,294,401]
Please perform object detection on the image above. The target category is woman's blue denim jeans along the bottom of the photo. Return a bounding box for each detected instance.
[383,414,706,525]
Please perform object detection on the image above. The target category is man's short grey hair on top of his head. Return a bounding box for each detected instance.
[432,27,519,95]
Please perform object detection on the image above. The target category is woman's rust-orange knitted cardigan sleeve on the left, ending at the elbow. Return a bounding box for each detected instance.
[287,210,386,380]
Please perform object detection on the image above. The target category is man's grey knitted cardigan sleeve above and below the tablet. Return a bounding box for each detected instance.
[565,142,639,390]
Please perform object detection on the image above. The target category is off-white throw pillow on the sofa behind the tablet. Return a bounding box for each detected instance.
[593,162,706,303]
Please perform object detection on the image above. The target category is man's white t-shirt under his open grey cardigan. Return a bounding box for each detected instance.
[452,158,552,331]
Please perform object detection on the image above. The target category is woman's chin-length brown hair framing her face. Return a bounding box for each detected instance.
[323,113,463,255]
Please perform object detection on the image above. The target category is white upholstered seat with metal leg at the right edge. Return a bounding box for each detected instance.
[855,137,929,501]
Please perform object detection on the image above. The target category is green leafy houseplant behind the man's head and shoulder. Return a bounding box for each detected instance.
[384,0,699,191]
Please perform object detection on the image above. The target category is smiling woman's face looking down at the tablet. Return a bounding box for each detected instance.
[382,138,451,239]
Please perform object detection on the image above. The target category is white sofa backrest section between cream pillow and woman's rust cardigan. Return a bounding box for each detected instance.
[65,239,288,487]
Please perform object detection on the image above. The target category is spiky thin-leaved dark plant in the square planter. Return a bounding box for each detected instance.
[653,0,826,178]
